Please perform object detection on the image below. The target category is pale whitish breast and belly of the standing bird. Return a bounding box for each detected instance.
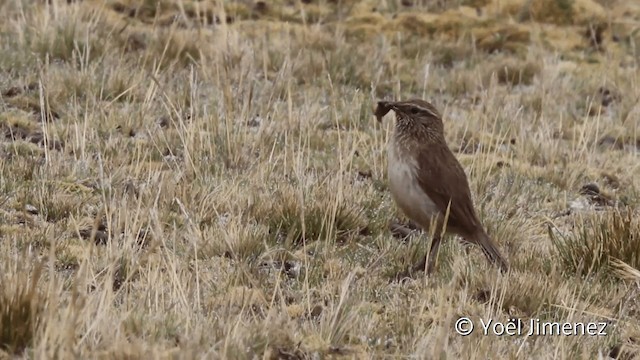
[387,142,440,224]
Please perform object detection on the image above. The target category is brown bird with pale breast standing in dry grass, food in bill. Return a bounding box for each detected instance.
[375,99,509,276]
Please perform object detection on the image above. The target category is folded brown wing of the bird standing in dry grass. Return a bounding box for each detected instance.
[417,146,479,233]
